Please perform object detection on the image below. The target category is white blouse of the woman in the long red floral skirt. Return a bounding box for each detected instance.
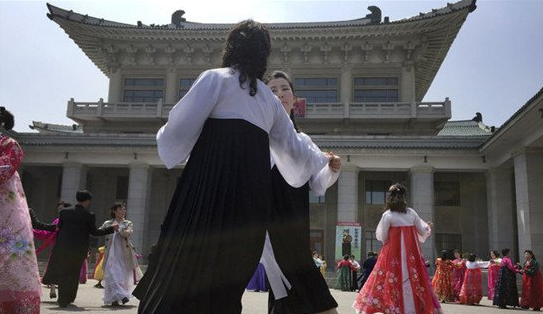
[375,207,432,243]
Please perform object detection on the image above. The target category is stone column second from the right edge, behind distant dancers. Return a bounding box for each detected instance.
[486,168,517,255]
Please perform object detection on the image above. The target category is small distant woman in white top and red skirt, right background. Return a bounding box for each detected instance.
[460,253,483,305]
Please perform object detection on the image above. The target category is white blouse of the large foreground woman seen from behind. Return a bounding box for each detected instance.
[157,68,328,187]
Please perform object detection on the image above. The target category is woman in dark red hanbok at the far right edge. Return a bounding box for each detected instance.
[520,250,543,311]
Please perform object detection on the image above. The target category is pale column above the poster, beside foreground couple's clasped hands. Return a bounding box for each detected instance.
[337,166,358,222]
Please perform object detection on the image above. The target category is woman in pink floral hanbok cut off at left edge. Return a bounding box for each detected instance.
[0,107,41,314]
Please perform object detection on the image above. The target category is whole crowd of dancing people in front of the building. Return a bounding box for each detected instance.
[0,20,542,314]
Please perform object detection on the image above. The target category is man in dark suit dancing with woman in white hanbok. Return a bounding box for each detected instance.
[42,190,118,307]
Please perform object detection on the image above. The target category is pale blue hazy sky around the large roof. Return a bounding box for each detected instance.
[0,0,543,132]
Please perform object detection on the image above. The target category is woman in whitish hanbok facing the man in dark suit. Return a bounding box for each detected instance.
[101,203,141,306]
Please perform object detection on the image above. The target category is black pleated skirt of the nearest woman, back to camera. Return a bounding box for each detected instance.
[133,119,272,314]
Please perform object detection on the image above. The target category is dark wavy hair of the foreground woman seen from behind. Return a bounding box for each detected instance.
[222,20,271,96]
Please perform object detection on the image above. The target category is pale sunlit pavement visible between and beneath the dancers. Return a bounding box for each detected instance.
[41,279,529,314]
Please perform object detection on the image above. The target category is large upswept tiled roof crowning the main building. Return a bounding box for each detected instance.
[48,0,476,101]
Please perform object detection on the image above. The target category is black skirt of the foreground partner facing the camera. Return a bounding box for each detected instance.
[268,167,338,314]
